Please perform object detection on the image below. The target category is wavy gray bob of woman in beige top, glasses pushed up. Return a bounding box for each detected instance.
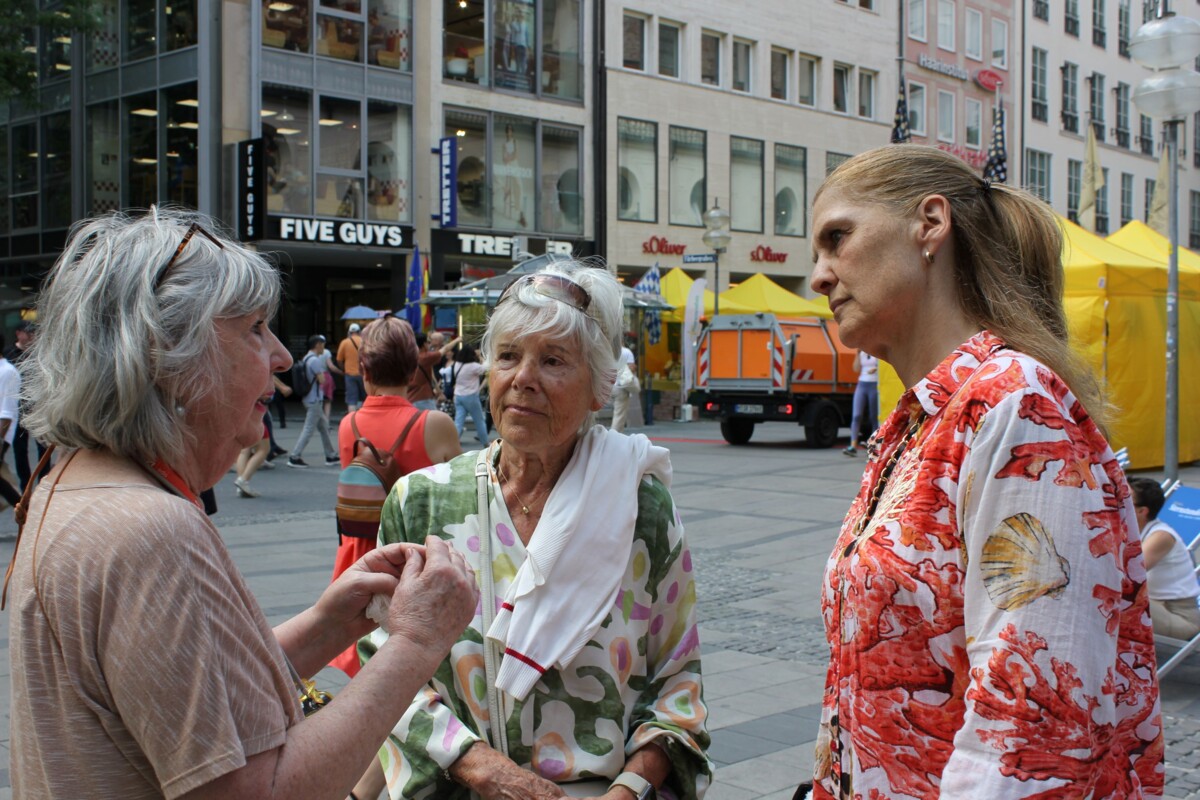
[20,207,280,462]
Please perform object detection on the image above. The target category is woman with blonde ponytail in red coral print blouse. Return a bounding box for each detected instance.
[811,145,1163,800]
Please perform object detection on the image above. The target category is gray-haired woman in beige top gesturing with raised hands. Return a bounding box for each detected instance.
[5,210,476,800]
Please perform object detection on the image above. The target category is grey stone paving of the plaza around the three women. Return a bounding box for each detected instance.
[0,417,1200,800]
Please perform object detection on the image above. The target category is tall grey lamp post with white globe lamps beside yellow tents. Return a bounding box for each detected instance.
[1129,0,1200,483]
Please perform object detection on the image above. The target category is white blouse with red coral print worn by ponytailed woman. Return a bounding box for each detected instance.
[815,331,1163,800]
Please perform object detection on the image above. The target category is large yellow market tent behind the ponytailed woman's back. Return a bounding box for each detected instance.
[1062,219,1200,468]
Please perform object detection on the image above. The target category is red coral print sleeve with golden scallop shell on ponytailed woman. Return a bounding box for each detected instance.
[941,383,1162,800]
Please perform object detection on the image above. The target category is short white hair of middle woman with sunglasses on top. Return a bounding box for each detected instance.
[482,260,625,429]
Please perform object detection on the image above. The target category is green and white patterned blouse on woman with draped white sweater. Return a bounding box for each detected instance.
[359,452,712,800]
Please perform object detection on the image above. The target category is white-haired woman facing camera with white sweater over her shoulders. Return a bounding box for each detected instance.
[360,263,712,800]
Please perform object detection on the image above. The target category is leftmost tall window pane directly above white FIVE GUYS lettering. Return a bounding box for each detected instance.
[260,85,312,215]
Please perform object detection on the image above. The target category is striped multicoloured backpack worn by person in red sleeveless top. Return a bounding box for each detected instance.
[334,410,425,541]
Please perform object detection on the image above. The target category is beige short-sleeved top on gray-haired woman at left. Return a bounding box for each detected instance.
[10,459,301,799]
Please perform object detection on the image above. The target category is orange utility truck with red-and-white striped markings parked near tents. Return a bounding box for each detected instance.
[689,313,858,447]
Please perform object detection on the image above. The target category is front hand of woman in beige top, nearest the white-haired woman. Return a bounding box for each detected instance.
[384,536,479,651]
